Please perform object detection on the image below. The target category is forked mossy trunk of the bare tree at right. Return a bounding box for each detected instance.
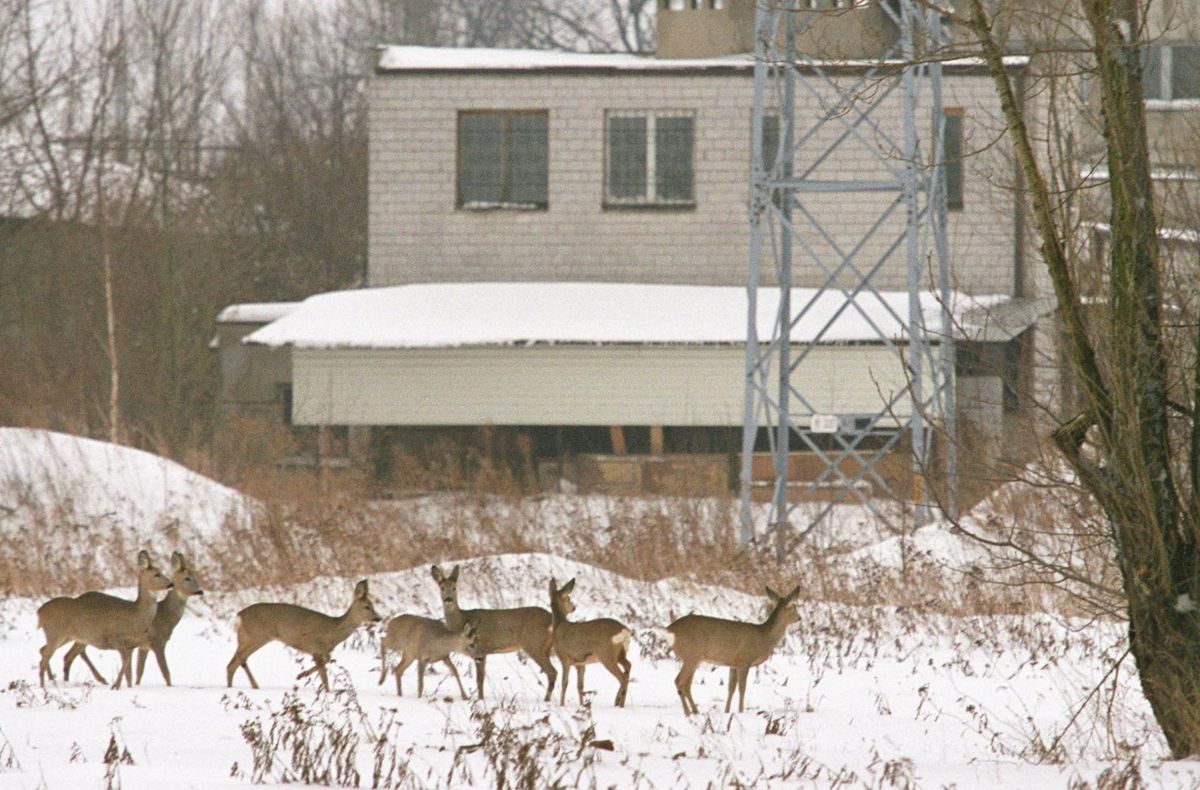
[967,0,1200,758]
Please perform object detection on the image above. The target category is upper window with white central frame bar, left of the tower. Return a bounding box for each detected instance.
[604,110,696,207]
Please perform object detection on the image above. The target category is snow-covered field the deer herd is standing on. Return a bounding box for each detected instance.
[0,427,1200,790]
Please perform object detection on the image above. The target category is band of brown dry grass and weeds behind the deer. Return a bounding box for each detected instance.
[0,423,1117,615]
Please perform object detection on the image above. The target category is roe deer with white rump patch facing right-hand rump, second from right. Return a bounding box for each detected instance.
[550,579,631,707]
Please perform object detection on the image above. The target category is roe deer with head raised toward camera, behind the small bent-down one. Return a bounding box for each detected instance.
[432,565,558,702]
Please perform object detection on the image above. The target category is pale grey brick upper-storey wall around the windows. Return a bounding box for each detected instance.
[368,67,1015,293]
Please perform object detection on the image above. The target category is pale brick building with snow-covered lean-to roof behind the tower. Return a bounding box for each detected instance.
[225,0,1040,492]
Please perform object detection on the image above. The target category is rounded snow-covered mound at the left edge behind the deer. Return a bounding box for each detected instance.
[0,427,253,543]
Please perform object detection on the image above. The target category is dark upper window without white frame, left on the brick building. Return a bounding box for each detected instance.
[458,110,548,209]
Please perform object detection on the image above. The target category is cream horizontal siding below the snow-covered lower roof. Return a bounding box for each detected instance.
[293,346,926,425]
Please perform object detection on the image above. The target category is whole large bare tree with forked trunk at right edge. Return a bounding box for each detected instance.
[944,0,1200,758]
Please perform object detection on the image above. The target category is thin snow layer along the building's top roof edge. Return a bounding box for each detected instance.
[376,46,1028,72]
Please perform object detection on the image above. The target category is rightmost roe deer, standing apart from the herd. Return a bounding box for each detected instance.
[667,585,800,714]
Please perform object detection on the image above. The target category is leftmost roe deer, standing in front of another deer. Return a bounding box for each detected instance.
[37,551,172,689]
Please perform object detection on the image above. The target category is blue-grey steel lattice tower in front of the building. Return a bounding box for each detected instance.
[740,0,956,555]
